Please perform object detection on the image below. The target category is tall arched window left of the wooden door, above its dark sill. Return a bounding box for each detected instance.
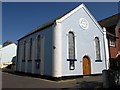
[68,32,75,59]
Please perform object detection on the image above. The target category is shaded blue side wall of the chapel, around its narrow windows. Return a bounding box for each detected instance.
[17,26,52,76]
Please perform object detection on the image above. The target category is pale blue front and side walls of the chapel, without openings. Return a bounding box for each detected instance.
[17,4,106,77]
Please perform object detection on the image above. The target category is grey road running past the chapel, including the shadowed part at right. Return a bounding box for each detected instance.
[2,72,102,89]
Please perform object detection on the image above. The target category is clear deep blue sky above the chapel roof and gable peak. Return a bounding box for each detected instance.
[2,2,118,43]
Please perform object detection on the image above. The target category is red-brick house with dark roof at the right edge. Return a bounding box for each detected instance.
[99,13,120,58]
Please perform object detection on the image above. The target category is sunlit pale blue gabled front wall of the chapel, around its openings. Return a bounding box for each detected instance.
[54,4,106,76]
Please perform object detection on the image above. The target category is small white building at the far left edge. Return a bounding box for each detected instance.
[0,43,17,68]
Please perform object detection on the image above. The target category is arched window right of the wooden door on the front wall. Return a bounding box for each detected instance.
[95,37,101,60]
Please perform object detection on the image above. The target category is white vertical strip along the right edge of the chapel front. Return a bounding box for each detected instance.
[103,27,109,70]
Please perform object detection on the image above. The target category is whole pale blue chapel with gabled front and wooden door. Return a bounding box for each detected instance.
[16,4,109,78]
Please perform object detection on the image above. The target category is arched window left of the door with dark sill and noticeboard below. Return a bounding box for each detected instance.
[67,32,77,70]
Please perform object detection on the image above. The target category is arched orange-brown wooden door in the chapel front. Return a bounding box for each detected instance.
[83,56,91,75]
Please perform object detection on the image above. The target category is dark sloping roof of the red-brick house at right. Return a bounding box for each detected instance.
[98,13,120,27]
